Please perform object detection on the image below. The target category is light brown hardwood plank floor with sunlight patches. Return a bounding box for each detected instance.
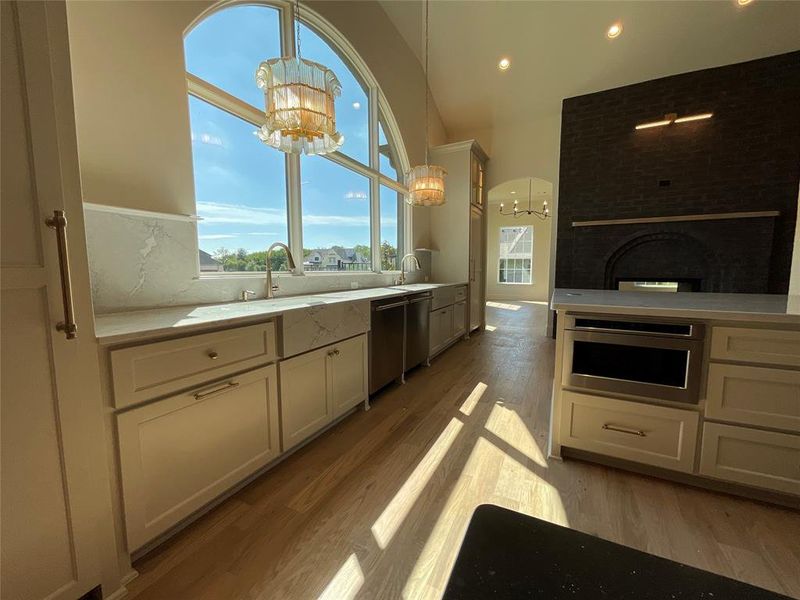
[129,302,800,600]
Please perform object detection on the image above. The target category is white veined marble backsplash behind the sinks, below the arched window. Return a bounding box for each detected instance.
[84,204,424,314]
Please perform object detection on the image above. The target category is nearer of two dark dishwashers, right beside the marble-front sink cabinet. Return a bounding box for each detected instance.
[369,298,408,394]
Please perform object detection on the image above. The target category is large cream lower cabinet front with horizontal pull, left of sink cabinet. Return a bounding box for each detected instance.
[117,365,280,552]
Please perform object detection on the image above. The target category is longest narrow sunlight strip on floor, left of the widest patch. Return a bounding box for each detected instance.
[372,418,464,550]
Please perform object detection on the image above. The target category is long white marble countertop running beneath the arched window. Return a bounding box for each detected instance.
[95,282,466,344]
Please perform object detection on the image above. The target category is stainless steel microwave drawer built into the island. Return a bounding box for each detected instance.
[562,316,705,404]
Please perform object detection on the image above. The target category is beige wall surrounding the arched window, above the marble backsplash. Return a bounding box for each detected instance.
[68,0,445,245]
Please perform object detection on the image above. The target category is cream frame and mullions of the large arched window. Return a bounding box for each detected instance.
[184,0,413,277]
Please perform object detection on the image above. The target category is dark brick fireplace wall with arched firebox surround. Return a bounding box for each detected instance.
[556,52,800,293]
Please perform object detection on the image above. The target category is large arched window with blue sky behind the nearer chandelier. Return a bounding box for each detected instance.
[184,3,411,272]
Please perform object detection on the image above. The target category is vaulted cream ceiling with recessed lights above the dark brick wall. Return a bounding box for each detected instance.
[379,0,800,132]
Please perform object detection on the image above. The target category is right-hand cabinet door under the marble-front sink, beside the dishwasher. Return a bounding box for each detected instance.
[331,335,368,419]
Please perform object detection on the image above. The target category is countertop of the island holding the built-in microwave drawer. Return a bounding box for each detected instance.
[550,288,800,323]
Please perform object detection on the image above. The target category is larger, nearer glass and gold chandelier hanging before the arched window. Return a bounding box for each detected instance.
[256,0,344,154]
